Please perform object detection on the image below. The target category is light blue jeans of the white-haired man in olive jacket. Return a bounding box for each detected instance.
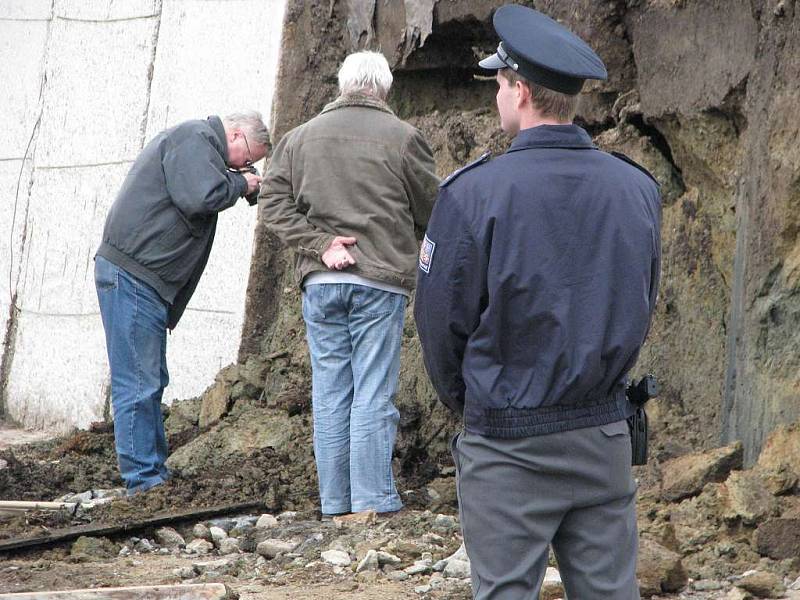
[303,283,406,514]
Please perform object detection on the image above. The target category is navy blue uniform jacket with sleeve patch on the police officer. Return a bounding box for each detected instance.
[414,125,661,438]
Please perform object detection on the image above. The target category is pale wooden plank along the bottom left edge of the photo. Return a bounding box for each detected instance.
[0,583,228,600]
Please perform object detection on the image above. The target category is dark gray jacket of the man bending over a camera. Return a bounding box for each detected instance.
[97,117,247,329]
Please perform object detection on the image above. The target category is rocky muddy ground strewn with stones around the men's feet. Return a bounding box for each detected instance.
[0,401,800,600]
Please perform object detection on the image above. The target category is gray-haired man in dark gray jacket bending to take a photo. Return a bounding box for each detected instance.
[95,111,269,494]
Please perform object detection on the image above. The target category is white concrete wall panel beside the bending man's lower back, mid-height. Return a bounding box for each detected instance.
[18,164,130,315]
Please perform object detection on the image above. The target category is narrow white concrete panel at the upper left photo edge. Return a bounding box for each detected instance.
[0,19,48,160]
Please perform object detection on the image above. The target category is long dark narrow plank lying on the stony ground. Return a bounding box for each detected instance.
[0,502,264,553]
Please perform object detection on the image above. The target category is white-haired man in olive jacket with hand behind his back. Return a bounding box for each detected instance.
[259,52,438,516]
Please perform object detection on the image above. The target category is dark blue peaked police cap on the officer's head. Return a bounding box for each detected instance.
[478,4,608,96]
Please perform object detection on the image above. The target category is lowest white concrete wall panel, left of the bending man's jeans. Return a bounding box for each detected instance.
[6,311,108,432]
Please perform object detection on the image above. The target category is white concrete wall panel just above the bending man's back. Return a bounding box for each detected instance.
[37,18,157,166]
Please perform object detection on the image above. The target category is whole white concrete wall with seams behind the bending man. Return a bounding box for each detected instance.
[0,0,285,431]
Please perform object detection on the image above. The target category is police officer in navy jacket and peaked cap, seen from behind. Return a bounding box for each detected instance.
[415,5,661,600]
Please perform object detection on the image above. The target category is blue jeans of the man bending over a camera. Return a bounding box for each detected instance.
[94,256,169,494]
